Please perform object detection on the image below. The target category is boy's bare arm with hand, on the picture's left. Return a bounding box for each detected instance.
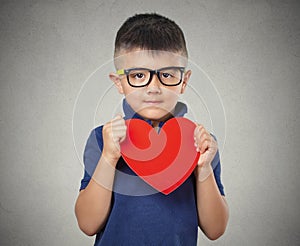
[75,117,126,236]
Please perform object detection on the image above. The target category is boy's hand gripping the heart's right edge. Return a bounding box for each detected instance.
[194,125,218,182]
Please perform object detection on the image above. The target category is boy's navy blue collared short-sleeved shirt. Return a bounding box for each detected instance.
[80,99,224,246]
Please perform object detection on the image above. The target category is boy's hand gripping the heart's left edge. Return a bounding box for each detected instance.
[102,115,127,165]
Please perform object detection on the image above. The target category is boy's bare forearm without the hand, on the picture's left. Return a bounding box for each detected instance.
[75,156,115,235]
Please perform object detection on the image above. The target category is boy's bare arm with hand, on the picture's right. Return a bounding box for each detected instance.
[194,125,229,240]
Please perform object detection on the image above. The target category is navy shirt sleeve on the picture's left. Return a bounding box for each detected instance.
[80,126,103,190]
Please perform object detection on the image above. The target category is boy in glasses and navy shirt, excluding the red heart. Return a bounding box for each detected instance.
[75,14,228,246]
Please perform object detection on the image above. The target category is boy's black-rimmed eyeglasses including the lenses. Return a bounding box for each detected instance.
[117,67,185,87]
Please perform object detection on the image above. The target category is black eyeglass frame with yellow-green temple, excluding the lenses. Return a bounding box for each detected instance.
[117,66,185,88]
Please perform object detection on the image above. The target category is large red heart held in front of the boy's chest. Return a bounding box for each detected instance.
[121,118,200,195]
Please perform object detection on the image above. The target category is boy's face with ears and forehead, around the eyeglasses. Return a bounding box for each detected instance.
[110,50,191,121]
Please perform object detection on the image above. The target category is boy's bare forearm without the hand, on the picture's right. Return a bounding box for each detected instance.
[195,170,229,240]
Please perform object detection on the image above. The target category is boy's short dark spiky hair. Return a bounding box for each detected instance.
[115,13,188,57]
